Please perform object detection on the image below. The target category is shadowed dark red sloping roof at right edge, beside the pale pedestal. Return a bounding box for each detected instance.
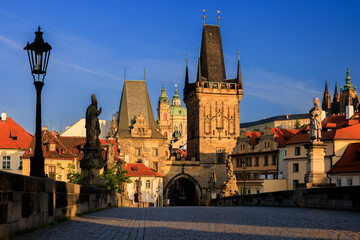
[328,143,360,173]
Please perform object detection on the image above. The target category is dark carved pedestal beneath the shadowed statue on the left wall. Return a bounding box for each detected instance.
[79,145,106,188]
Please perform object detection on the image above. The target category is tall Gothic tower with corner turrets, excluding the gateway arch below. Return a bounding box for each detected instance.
[184,24,243,163]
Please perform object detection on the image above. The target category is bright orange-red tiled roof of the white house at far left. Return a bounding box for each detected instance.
[0,117,32,149]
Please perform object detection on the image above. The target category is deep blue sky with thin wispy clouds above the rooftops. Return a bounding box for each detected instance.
[0,0,360,133]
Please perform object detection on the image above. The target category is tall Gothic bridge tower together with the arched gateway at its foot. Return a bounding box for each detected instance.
[164,19,243,205]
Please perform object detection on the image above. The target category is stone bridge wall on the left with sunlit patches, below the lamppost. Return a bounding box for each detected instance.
[0,171,149,239]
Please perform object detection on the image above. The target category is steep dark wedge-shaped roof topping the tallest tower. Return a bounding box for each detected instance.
[200,25,226,82]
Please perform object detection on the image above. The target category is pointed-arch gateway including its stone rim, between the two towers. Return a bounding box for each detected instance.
[164,173,201,206]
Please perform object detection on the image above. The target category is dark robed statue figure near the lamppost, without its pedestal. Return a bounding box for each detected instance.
[85,94,102,146]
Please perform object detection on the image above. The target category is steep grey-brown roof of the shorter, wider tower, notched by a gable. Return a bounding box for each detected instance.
[116,80,165,139]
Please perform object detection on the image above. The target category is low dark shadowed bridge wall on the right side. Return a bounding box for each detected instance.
[211,186,360,211]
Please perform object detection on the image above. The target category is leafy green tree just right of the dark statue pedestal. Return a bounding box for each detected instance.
[101,164,132,192]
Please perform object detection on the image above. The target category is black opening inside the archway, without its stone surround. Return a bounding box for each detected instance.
[168,177,199,206]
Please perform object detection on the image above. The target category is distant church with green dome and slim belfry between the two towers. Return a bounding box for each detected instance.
[157,83,187,144]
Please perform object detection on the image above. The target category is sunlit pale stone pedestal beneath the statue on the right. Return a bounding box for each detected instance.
[304,141,328,188]
